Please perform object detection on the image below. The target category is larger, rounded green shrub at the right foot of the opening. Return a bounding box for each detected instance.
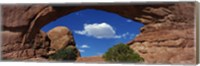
[103,43,144,62]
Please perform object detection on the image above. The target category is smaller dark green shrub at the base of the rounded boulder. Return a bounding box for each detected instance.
[49,46,77,61]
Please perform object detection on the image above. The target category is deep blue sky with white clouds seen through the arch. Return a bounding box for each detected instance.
[41,9,143,57]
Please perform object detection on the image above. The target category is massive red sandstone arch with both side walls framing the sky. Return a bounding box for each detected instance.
[1,3,196,63]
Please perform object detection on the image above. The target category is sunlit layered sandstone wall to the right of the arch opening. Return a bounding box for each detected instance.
[129,3,196,64]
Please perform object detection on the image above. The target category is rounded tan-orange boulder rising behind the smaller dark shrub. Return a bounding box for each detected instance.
[47,26,75,51]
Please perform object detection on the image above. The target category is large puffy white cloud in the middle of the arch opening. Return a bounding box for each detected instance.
[75,23,120,39]
